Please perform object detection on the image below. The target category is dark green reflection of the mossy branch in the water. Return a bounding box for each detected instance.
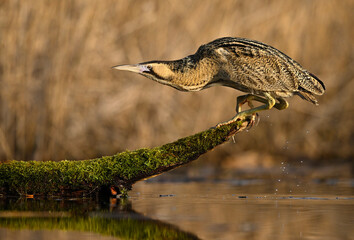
[0,199,198,240]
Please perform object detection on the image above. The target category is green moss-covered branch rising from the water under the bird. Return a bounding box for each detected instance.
[0,118,251,197]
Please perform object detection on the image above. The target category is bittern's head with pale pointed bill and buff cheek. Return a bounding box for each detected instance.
[113,61,180,87]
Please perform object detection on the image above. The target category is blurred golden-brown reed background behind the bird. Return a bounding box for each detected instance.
[0,0,354,172]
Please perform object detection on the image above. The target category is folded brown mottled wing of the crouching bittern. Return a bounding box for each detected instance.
[219,42,306,92]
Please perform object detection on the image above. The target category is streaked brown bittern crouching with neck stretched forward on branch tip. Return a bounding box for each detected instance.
[113,37,325,126]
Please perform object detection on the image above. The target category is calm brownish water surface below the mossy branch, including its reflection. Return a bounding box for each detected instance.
[0,179,354,240]
